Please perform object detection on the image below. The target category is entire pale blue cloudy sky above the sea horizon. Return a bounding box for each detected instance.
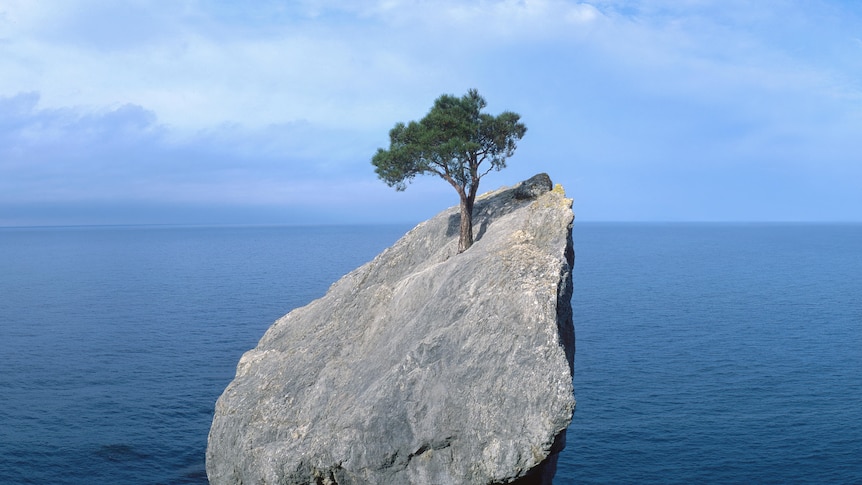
[0,0,862,226]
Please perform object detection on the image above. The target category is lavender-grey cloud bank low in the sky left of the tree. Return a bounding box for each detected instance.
[0,93,388,210]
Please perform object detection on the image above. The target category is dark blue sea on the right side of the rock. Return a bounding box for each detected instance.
[560,225,862,484]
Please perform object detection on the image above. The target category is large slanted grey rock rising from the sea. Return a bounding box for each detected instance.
[207,174,575,485]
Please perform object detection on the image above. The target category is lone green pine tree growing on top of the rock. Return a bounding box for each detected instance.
[371,89,527,253]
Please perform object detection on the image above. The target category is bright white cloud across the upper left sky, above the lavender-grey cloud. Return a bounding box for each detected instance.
[0,0,608,128]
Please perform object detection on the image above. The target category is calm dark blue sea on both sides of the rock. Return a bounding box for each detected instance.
[0,222,862,484]
